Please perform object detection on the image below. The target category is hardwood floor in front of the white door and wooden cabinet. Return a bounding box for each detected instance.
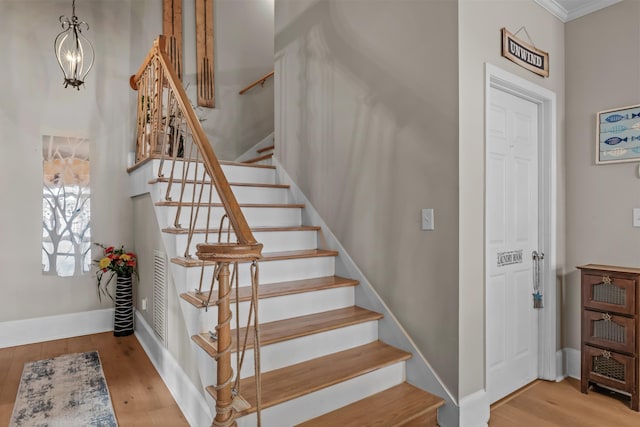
[489,378,640,427]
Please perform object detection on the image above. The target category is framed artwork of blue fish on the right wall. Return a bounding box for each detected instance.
[596,105,640,165]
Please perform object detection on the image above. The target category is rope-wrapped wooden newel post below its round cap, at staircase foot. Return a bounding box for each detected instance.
[213,262,237,427]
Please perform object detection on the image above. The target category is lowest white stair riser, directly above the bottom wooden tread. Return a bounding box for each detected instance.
[237,362,404,427]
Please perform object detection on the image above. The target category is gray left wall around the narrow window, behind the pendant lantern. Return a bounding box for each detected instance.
[0,0,133,322]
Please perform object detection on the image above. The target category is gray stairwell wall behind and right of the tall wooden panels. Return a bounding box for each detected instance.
[182,0,273,160]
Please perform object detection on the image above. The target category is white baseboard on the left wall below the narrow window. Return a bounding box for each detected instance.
[0,308,113,348]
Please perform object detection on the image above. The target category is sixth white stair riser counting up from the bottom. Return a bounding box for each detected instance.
[156,206,302,230]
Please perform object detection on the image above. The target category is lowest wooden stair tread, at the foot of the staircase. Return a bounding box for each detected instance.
[296,383,444,427]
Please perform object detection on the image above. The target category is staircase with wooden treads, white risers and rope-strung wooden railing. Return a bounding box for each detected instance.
[130,36,442,427]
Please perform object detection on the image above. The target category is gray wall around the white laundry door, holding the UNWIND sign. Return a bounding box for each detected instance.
[459,0,565,396]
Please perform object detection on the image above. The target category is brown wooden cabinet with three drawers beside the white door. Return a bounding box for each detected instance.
[578,264,640,411]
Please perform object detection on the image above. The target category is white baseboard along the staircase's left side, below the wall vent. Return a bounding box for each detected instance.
[136,312,213,426]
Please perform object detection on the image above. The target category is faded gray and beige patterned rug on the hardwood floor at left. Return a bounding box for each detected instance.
[9,351,118,427]
